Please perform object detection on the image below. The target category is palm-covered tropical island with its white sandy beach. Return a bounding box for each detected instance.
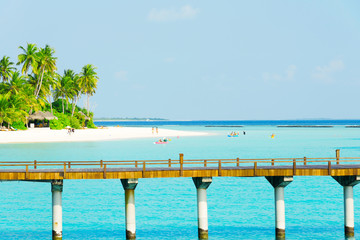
[0,43,205,143]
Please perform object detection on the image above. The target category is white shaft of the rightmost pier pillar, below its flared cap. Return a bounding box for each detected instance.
[344,186,354,237]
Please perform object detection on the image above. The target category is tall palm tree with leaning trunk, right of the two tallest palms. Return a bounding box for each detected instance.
[34,45,56,98]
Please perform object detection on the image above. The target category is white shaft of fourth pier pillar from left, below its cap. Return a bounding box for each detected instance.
[274,187,285,238]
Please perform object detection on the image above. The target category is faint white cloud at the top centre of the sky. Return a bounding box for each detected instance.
[148,5,199,22]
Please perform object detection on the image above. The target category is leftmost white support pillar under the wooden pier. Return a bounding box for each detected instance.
[51,180,63,240]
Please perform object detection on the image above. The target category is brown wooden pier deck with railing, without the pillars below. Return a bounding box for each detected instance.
[0,154,360,181]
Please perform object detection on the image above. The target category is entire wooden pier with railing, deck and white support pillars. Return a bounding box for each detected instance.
[0,150,360,239]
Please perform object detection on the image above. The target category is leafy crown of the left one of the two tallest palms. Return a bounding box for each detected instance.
[17,43,38,75]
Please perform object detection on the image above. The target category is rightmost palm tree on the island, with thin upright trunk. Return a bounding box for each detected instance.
[79,64,99,115]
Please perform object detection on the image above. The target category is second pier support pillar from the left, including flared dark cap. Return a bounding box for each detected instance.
[121,178,138,240]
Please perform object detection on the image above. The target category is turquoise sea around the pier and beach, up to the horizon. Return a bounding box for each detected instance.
[0,120,360,240]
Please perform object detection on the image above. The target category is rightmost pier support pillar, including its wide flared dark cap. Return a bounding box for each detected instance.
[333,176,360,237]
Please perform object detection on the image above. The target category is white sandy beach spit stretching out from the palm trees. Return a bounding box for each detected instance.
[0,127,208,144]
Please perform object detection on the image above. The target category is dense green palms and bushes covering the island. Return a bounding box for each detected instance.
[0,44,99,129]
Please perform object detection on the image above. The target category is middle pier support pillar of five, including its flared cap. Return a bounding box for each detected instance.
[193,177,212,239]
